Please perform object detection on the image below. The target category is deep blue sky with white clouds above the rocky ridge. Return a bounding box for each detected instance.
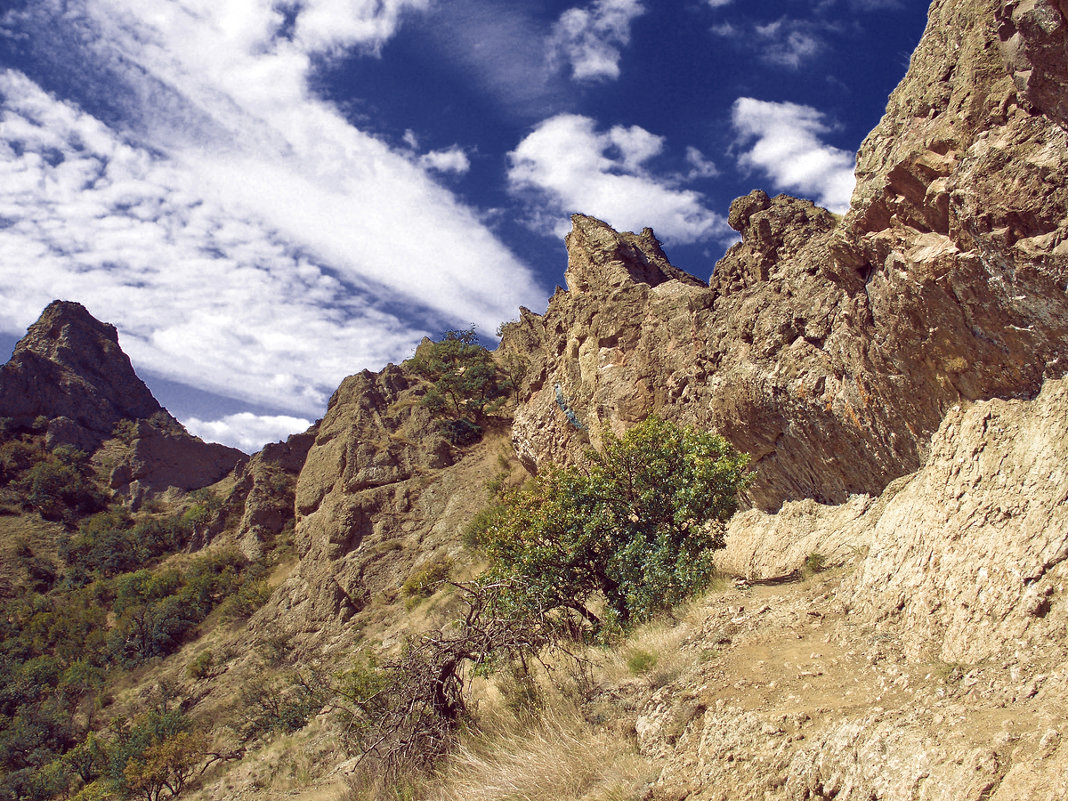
[0,0,927,452]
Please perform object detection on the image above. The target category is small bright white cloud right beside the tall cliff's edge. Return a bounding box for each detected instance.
[732,97,855,213]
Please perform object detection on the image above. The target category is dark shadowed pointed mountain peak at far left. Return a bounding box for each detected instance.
[0,300,246,495]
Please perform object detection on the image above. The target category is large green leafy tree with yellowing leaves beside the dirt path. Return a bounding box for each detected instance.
[476,417,749,630]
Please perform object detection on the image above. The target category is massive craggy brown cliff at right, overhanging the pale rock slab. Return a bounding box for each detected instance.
[502,0,1068,508]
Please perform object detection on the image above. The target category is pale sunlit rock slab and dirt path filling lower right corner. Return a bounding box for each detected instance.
[635,380,1068,801]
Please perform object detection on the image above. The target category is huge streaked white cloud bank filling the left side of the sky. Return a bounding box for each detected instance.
[0,0,544,427]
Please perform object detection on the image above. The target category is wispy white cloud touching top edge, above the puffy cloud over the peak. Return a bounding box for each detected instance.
[550,0,645,81]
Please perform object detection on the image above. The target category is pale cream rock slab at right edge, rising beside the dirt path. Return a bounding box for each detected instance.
[845,381,1068,663]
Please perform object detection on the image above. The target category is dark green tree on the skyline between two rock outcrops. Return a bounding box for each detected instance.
[407,327,512,444]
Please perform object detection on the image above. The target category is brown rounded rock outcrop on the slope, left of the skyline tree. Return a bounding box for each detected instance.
[253,364,512,647]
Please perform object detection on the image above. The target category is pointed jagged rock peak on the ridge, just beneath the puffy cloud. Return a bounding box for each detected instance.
[564,215,705,293]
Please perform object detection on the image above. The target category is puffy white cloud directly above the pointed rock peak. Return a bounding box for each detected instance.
[508,114,726,244]
